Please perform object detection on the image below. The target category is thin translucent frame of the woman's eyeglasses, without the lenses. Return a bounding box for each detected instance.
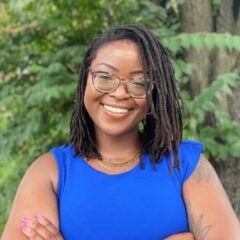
[89,68,153,99]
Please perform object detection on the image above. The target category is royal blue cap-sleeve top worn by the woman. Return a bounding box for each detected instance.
[51,141,203,240]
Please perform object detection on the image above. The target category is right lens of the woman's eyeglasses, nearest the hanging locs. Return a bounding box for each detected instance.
[127,80,149,98]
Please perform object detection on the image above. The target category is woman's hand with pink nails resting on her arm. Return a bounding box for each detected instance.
[21,213,64,240]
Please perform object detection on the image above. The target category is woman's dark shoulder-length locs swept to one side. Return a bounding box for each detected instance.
[69,25,182,167]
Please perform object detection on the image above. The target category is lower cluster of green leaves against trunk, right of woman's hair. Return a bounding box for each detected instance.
[184,73,240,160]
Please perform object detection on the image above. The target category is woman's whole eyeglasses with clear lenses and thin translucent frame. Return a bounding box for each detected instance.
[89,69,153,98]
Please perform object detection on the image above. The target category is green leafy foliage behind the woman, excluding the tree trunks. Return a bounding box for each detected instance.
[0,0,240,233]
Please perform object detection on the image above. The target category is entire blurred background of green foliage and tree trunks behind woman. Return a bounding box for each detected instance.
[0,0,240,234]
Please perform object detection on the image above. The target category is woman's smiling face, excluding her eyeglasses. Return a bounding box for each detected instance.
[84,40,147,137]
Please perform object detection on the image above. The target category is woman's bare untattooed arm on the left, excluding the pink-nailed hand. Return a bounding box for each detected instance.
[2,153,59,240]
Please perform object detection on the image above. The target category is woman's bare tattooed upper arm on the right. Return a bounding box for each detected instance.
[183,156,240,240]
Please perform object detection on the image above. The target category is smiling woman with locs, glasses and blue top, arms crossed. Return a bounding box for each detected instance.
[2,25,240,240]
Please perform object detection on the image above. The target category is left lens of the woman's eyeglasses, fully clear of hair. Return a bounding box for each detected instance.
[94,72,118,92]
